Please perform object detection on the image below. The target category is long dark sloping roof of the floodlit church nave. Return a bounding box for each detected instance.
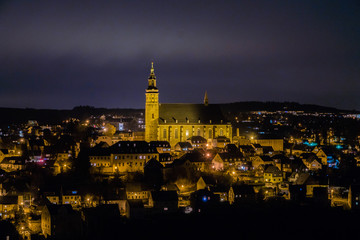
[159,103,227,124]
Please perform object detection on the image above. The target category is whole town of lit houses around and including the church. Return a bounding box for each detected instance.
[0,64,360,239]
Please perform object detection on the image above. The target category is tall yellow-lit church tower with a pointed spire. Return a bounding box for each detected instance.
[145,62,159,142]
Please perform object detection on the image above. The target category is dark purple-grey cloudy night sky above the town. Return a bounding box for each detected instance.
[0,0,360,110]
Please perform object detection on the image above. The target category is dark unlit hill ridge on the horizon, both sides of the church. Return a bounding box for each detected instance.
[0,102,359,126]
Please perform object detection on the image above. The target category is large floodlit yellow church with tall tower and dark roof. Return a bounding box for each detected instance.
[145,63,232,147]
